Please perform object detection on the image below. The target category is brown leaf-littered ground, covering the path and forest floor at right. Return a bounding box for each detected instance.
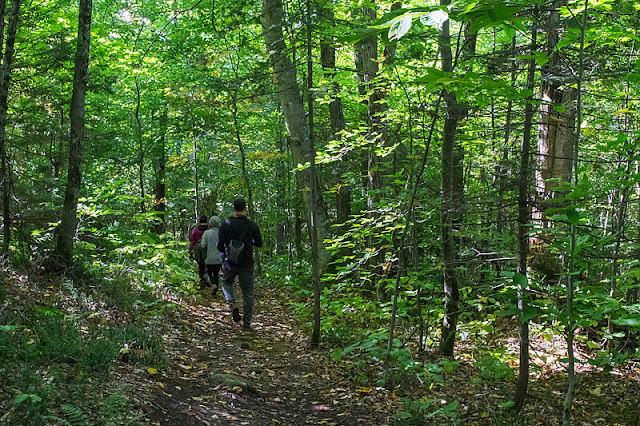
[0,275,640,426]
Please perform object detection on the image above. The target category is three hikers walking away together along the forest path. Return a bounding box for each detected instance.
[189,198,262,331]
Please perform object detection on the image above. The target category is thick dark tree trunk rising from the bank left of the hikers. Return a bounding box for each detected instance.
[55,0,92,265]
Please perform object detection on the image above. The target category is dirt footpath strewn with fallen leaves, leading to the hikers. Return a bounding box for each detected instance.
[127,286,395,425]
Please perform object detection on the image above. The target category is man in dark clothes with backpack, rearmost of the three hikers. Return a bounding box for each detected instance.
[218,198,262,331]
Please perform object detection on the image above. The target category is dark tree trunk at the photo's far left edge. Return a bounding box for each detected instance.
[0,0,20,256]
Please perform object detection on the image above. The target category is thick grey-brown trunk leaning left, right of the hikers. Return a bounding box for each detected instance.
[261,0,330,271]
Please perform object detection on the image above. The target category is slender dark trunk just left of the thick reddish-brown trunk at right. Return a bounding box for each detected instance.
[515,14,538,411]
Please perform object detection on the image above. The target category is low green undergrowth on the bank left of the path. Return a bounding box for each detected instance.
[0,233,194,425]
